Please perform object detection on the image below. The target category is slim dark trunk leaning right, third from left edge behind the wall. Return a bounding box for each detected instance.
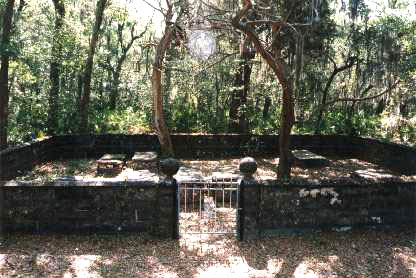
[79,0,107,133]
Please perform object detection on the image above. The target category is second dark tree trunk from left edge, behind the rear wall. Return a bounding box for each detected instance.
[48,0,65,135]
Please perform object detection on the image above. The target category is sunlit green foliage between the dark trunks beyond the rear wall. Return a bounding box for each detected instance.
[0,0,416,147]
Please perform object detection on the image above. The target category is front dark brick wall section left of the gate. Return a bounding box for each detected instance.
[0,181,178,238]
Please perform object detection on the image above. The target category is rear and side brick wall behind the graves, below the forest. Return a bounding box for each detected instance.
[0,134,416,180]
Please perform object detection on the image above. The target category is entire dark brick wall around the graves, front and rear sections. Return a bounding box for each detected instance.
[0,135,416,238]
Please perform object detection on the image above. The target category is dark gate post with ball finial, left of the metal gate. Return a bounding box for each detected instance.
[155,158,179,239]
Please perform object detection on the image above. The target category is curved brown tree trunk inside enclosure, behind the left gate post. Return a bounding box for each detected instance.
[152,20,174,156]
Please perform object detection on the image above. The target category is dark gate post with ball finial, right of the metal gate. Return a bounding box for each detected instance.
[237,157,260,241]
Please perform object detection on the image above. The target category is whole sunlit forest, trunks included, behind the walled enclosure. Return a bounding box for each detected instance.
[0,0,416,152]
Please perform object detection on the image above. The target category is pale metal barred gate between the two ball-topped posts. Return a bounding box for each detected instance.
[178,175,239,235]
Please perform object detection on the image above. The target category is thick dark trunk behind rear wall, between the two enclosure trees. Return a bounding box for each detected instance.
[229,38,255,133]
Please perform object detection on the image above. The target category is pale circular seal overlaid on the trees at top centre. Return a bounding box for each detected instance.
[188,30,217,60]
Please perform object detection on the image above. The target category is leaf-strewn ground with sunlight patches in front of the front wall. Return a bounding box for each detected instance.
[0,230,416,278]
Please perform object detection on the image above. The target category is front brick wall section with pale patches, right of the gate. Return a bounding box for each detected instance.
[239,181,416,239]
